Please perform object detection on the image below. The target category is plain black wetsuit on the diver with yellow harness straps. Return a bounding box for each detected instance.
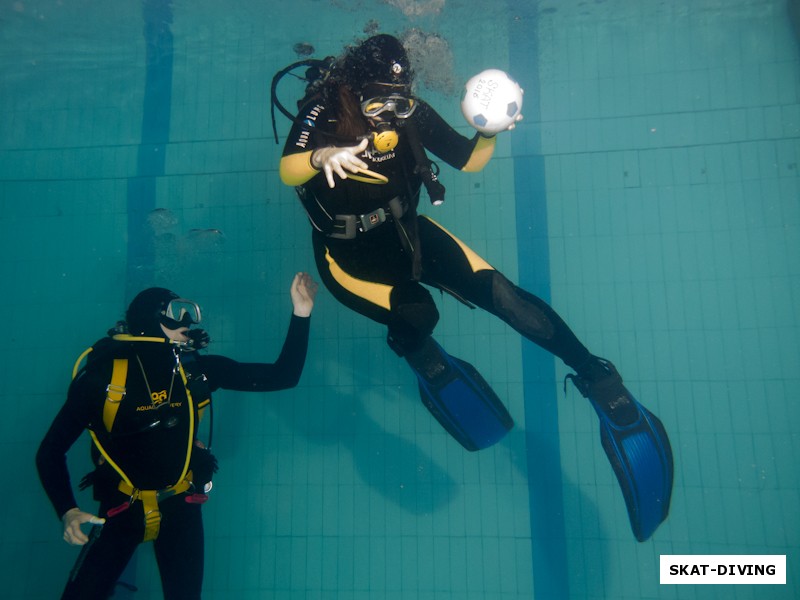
[36,315,310,600]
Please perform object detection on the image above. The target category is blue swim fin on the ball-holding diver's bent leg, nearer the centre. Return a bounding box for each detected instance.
[405,338,514,451]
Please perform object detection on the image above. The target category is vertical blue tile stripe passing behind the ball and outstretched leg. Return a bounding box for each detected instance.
[508,0,569,600]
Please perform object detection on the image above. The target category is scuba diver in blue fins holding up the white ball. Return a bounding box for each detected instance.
[272,34,673,541]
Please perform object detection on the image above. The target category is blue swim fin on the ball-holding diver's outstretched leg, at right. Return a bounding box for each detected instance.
[568,357,674,542]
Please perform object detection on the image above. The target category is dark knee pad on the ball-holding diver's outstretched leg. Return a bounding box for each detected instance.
[492,271,555,340]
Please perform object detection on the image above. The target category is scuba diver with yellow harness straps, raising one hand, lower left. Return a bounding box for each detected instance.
[36,273,317,600]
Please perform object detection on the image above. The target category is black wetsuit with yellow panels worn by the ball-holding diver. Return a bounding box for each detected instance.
[281,100,590,369]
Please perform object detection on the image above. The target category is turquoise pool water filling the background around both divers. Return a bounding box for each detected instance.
[0,0,800,600]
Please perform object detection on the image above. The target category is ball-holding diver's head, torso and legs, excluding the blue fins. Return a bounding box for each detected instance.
[280,35,593,390]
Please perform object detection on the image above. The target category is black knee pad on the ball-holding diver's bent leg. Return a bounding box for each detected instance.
[389,282,439,356]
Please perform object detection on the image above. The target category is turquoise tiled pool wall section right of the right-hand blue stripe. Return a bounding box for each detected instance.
[539,1,800,598]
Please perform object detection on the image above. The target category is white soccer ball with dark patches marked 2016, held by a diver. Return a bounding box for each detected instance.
[461,69,523,135]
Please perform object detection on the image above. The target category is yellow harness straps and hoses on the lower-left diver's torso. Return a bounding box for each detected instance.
[72,334,211,542]
